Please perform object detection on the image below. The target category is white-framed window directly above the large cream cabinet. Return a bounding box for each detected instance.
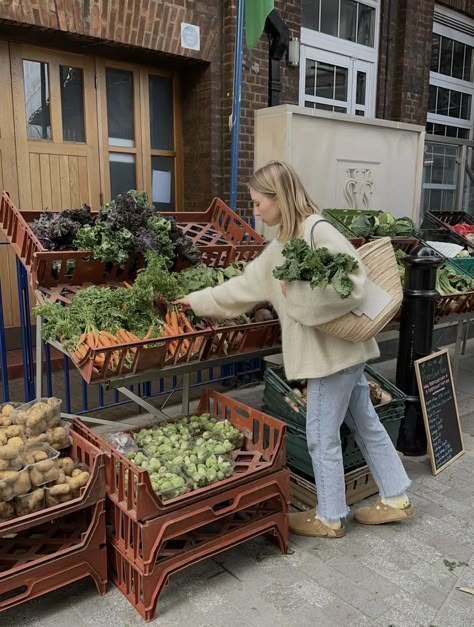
[299,0,379,116]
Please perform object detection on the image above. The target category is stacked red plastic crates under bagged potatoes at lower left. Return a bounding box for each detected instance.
[0,432,107,624]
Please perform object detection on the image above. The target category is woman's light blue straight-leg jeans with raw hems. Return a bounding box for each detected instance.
[306,364,411,520]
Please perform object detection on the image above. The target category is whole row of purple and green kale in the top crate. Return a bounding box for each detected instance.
[32,190,200,269]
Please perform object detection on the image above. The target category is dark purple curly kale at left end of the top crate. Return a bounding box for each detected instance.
[31,205,95,250]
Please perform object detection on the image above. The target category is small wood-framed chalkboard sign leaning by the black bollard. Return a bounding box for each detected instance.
[415,350,464,475]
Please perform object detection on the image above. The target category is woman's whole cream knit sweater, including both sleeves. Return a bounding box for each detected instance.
[189,215,379,379]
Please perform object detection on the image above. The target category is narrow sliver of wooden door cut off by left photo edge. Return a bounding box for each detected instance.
[0,41,19,327]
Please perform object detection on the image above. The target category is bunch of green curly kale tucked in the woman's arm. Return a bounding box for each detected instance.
[273,237,359,298]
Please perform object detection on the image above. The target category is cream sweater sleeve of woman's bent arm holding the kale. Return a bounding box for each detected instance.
[286,222,366,327]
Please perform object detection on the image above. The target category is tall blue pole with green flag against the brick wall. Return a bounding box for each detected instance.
[230,0,245,211]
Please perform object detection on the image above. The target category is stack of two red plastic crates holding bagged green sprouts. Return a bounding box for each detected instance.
[73,390,289,621]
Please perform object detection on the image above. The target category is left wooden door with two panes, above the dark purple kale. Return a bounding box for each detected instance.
[10,43,100,210]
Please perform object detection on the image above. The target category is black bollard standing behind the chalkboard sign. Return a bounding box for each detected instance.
[396,245,443,455]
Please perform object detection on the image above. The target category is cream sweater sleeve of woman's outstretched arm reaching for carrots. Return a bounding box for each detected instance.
[188,244,272,318]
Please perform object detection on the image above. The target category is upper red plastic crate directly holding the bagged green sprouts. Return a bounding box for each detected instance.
[72,389,286,522]
